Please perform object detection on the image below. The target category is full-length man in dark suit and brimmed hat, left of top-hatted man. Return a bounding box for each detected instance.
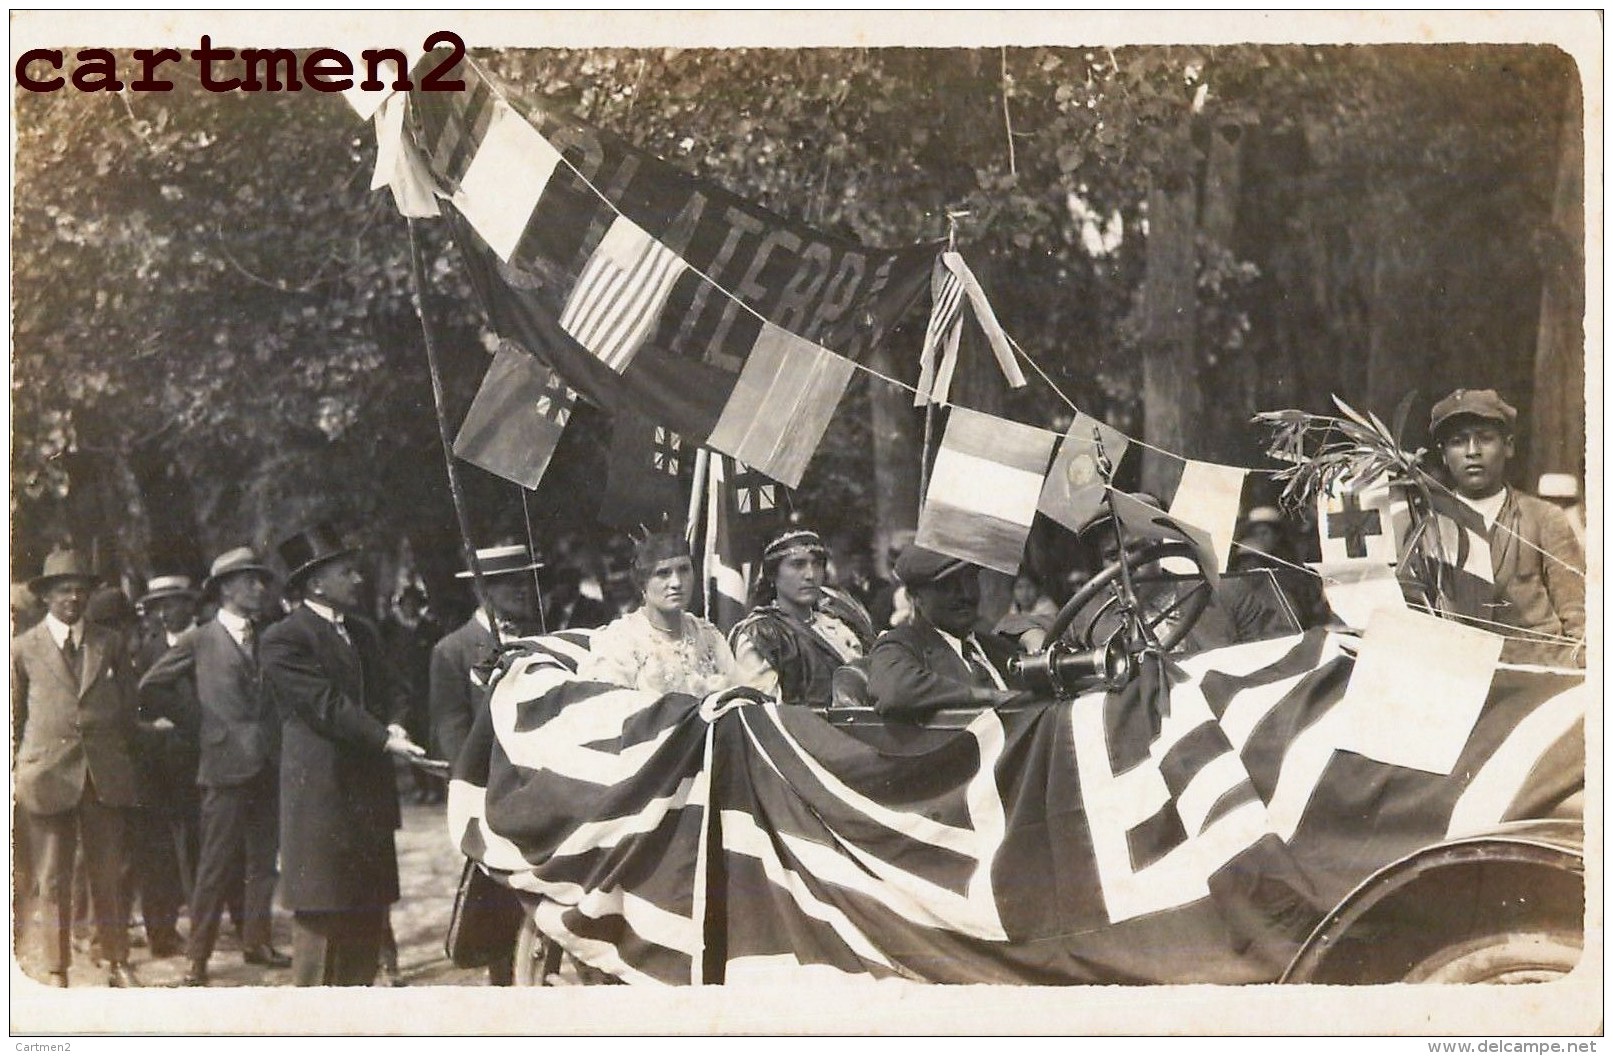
[140,547,290,987]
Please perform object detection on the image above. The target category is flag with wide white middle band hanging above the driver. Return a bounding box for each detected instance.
[915,406,1058,576]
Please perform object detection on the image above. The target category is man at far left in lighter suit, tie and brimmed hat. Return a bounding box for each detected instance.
[11,550,139,987]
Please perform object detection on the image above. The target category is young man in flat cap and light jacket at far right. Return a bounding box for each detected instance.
[1408,389,1586,666]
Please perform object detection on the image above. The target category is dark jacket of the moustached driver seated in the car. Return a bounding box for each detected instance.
[868,613,1015,717]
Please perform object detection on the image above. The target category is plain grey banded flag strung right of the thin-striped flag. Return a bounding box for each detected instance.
[706,322,855,489]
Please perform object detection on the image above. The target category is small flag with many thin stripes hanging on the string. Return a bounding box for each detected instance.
[560,216,687,374]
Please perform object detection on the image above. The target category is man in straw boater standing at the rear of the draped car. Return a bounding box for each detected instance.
[431,543,544,987]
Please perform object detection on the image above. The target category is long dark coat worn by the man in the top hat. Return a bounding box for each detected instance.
[258,606,403,913]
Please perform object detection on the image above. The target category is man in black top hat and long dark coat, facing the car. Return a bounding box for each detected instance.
[258,524,424,987]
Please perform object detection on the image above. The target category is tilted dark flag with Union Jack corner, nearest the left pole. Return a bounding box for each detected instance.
[453,342,577,489]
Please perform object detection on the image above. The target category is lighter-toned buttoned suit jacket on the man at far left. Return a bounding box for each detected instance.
[11,622,139,814]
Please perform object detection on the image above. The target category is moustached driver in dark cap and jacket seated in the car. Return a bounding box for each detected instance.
[868,547,1027,721]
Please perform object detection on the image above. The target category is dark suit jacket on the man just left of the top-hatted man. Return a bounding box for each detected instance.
[140,619,281,788]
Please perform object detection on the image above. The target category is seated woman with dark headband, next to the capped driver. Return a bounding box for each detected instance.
[729,529,873,708]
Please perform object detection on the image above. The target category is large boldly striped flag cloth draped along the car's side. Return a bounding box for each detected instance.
[448,630,1589,985]
